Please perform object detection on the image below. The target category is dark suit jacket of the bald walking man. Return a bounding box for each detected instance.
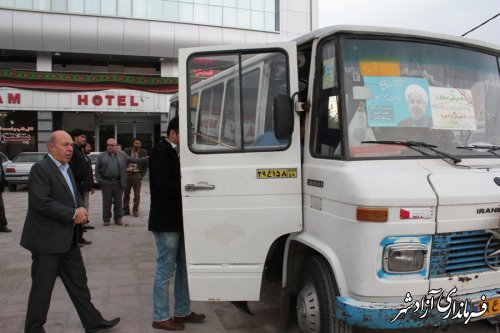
[21,155,83,253]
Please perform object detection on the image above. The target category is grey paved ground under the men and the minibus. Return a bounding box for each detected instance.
[0,182,496,333]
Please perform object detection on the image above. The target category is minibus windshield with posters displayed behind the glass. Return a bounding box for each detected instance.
[336,37,500,159]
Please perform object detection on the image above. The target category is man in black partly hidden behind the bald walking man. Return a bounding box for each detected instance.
[69,128,93,245]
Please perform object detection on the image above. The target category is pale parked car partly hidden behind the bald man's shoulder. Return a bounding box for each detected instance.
[4,152,47,192]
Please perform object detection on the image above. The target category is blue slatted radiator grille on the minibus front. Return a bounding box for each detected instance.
[430,230,500,278]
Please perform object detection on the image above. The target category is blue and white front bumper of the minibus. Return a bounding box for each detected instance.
[336,288,500,329]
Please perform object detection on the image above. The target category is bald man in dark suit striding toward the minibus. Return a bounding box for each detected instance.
[21,131,120,333]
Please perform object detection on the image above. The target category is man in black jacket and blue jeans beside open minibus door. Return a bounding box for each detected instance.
[148,117,205,331]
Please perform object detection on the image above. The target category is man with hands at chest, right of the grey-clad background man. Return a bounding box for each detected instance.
[123,138,148,217]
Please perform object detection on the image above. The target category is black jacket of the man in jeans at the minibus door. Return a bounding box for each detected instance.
[148,137,182,232]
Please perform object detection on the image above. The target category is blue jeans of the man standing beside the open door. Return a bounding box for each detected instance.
[153,232,191,321]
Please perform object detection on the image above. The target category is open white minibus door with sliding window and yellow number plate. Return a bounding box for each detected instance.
[178,43,302,301]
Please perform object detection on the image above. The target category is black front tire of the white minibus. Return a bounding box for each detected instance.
[297,256,352,333]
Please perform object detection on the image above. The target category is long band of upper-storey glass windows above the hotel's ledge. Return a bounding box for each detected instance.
[0,0,278,31]
